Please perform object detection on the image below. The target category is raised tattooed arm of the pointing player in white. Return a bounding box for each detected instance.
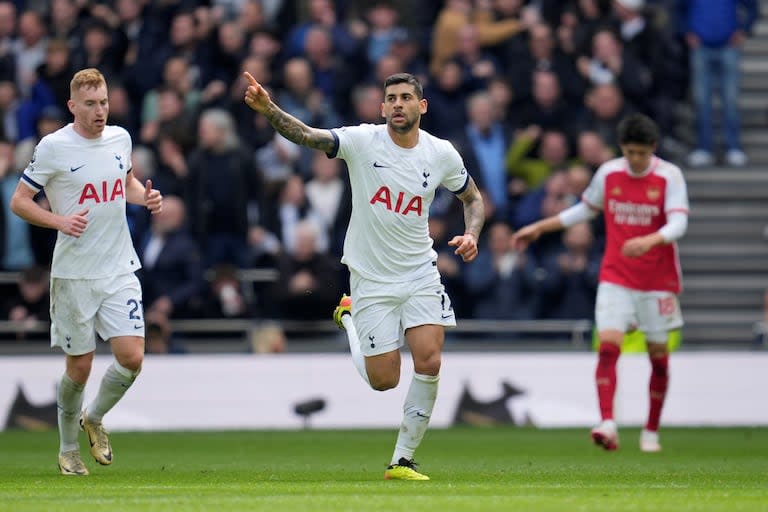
[244,71,335,153]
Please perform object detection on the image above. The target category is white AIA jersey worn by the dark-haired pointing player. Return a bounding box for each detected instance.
[329,124,469,282]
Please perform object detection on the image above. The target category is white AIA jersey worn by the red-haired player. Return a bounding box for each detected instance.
[21,123,141,279]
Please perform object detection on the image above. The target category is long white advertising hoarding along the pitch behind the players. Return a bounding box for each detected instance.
[0,352,768,430]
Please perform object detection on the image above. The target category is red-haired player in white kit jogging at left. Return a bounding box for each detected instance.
[11,68,162,475]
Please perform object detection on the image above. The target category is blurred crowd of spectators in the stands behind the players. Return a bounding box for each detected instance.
[0,0,754,348]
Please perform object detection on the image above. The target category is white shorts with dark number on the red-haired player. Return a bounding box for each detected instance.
[51,274,144,356]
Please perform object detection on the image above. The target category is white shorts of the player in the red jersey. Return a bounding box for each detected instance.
[595,283,683,343]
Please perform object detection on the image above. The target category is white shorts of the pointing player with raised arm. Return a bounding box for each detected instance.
[350,269,456,356]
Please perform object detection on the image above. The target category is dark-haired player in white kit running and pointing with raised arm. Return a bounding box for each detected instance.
[245,73,485,480]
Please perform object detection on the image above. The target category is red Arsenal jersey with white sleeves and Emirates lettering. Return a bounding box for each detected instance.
[582,156,688,293]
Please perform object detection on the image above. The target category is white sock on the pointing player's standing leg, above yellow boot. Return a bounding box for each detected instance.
[392,373,440,464]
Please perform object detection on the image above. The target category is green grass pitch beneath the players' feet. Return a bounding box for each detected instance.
[0,427,768,512]
